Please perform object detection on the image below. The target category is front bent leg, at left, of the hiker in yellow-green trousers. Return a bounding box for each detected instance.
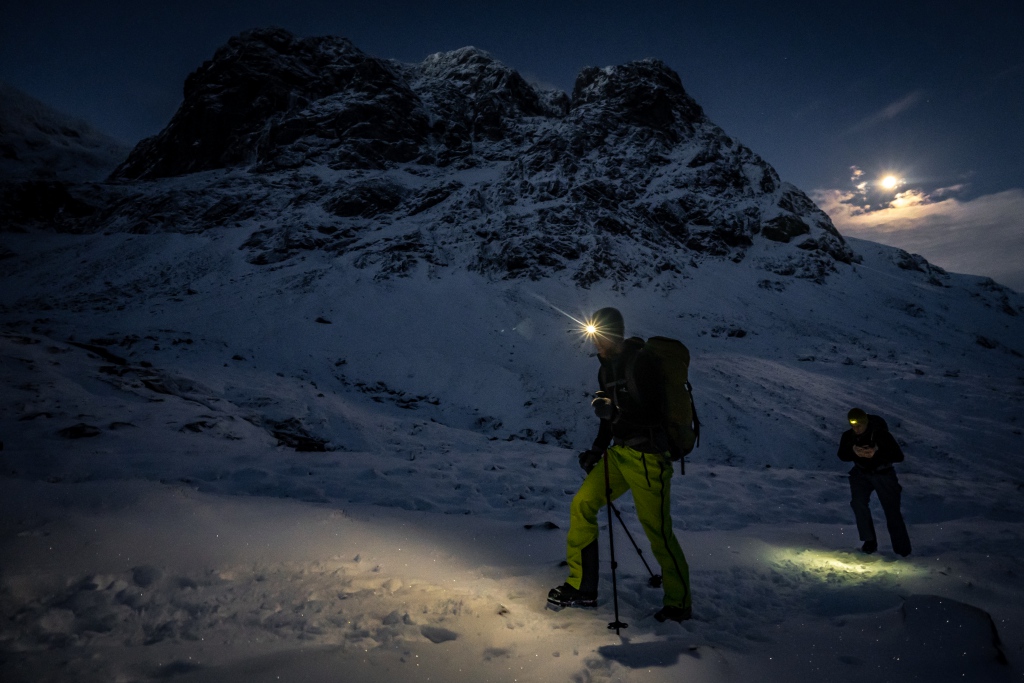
[565,448,628,595]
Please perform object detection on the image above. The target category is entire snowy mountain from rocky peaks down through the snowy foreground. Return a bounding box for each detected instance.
[0,30,1024,682]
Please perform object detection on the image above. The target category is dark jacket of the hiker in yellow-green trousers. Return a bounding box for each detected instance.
[592,337,669,453]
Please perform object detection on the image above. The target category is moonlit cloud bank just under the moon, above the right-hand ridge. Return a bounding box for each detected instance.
[812,186,1024,292]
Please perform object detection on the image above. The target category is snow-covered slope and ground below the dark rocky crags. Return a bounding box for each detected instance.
[0,230,1024,683]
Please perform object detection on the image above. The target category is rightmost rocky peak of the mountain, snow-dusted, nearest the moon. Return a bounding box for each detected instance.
[468,60,854,286]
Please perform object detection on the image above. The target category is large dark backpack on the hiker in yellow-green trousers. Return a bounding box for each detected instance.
[627,337,700,473]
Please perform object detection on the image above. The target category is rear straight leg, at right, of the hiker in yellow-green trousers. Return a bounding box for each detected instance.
[612,449,691,610]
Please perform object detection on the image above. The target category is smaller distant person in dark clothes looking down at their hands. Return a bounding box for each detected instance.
[839,408,910,557]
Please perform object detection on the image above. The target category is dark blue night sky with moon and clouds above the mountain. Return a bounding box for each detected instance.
[0,0,1024,290]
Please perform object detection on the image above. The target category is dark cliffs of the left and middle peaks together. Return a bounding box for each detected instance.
[113,30,568,179]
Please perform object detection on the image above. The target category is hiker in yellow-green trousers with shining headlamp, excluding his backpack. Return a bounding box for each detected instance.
[548,308,692,622]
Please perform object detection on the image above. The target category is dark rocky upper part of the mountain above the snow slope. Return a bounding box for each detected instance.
[4,29,858,287]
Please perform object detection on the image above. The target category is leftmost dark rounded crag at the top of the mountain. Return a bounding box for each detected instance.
[113,30,427,179]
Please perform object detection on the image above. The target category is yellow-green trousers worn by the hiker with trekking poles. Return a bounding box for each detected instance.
[565,445,690,607]
